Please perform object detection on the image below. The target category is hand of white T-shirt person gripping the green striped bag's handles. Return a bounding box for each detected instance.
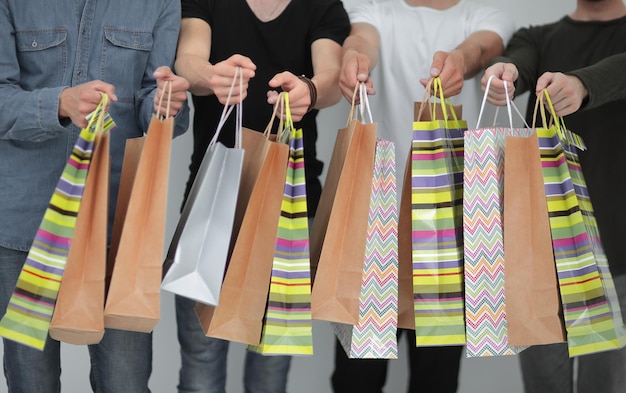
[420,51,465,98]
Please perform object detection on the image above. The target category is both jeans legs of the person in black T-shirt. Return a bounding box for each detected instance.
[176,296,291,393]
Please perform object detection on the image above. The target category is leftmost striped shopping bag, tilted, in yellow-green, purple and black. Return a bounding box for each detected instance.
[0,94,115,350]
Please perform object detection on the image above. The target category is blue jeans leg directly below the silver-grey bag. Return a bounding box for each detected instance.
[176,296,229,393]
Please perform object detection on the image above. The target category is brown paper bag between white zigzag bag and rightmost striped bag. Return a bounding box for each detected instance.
[503,133,565,346]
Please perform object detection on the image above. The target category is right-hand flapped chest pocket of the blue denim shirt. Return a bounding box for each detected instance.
[101,26,153,102]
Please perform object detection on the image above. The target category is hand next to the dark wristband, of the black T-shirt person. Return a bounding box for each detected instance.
[267,71,315,122]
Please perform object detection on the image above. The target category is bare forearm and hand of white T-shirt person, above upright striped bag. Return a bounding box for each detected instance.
[421,31,504,97]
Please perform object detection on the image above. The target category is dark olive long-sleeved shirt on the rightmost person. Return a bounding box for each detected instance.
[504,17,626,275]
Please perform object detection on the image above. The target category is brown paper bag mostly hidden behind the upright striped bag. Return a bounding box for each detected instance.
[398,101,463,330]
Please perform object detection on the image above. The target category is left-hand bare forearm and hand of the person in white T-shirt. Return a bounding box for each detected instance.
[339,23,380,101]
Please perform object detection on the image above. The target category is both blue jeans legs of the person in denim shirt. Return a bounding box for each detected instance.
[0,247,152,393]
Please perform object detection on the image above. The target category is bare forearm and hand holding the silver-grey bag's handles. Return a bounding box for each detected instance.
[175,18,256,104]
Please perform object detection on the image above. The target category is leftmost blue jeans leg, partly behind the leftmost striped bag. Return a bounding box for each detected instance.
[0,247,61,393]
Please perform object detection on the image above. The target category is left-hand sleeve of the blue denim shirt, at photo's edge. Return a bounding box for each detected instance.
[0,1,69,142]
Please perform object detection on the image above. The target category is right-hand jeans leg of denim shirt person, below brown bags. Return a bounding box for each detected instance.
[89,329,152,393]
